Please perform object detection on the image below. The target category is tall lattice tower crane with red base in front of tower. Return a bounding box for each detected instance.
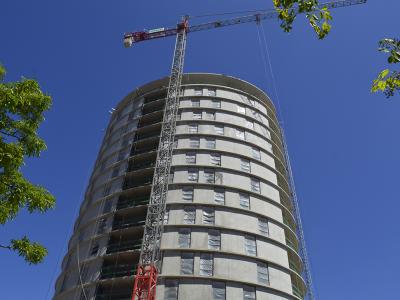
[124,0,367,300]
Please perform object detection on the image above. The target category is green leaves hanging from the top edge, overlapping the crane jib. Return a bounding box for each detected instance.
[272,0,332,39]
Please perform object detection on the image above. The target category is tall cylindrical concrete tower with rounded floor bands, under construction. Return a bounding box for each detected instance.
[54,73,306,300]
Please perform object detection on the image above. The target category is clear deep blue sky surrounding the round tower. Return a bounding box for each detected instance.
[0,0,400,300]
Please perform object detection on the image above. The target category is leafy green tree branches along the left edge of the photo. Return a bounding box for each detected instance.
[0,65,55,264]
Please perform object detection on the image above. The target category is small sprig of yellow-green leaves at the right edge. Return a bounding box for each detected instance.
[371,39,400,98]
